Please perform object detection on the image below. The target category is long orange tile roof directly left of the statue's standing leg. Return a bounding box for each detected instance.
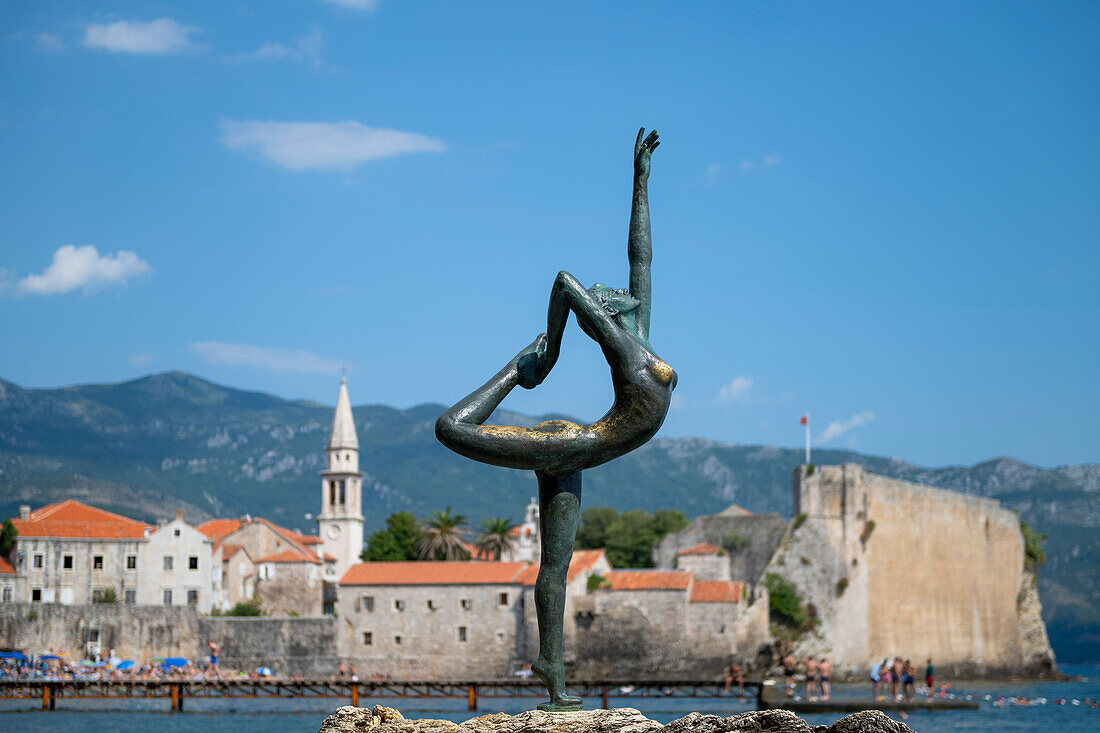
[340,560,527,586]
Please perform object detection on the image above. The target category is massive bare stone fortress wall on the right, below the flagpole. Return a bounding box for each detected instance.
[766,464,1054,676]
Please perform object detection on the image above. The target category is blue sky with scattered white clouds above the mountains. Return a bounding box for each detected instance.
[0,0,1100,466]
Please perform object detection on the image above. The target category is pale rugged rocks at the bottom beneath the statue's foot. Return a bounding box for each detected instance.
[319,705,913,733]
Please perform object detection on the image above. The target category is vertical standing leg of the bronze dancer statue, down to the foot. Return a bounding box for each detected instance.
[531,471,582,712]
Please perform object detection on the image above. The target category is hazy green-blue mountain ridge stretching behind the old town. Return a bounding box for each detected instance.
[0,372,1100,660]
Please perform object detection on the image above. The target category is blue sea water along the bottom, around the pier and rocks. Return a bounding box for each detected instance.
[0,666,1100,733]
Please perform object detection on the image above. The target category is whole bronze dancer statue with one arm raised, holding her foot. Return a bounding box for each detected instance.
[436,128,677,711]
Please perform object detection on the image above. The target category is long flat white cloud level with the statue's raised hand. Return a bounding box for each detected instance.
[221,120,446,171]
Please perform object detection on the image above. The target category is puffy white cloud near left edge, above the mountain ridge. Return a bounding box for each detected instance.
[6,244,153,295]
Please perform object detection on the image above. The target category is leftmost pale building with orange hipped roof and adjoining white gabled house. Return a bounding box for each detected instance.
[11,500,220,612]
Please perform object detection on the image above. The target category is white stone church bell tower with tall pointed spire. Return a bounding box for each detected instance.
[317,378,363,579]
